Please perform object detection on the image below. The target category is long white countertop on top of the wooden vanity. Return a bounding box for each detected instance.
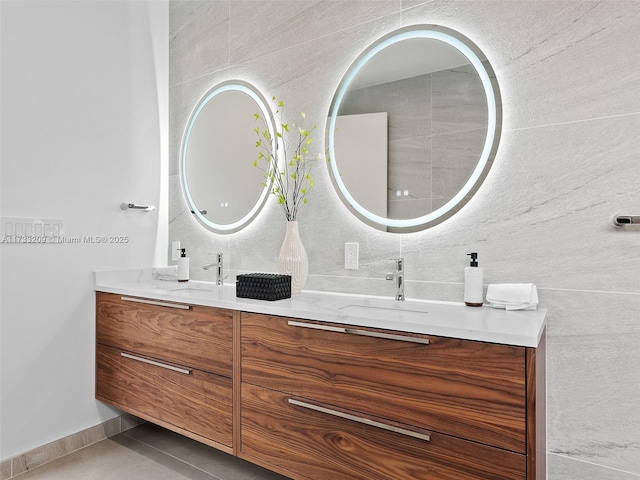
[95,269,547,347]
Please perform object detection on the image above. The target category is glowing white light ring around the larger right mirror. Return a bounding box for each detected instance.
[328,25,502,232]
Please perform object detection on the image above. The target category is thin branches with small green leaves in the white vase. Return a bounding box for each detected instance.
[253,97,317,221]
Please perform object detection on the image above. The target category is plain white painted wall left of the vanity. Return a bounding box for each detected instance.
[0,0,168,459]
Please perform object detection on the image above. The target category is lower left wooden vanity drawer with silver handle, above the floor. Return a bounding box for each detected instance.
[96,345,233,447]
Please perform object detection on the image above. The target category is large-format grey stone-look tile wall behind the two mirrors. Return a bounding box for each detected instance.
[169,0,640,480]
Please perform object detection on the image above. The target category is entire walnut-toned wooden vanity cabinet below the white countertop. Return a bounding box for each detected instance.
[96,292,546,480]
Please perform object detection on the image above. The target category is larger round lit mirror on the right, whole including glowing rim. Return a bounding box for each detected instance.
[327,25,502,232]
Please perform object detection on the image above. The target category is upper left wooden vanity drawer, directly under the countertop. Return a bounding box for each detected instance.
[96,292,233,377]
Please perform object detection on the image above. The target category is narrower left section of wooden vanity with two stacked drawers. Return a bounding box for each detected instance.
[96,292,233,453]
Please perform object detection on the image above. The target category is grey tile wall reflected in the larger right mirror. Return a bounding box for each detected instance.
[336,55,487,219]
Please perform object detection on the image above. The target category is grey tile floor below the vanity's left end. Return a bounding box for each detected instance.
[15,423,287,480]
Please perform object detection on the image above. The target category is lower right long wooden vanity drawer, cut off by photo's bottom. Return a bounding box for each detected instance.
[241,384,526,480]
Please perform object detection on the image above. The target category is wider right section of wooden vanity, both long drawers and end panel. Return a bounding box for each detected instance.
[239,312,546,480]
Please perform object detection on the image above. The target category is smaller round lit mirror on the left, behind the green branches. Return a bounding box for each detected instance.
[180,81,276,233]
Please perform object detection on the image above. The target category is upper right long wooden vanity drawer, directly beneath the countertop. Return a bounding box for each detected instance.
[241,312,526,453]
